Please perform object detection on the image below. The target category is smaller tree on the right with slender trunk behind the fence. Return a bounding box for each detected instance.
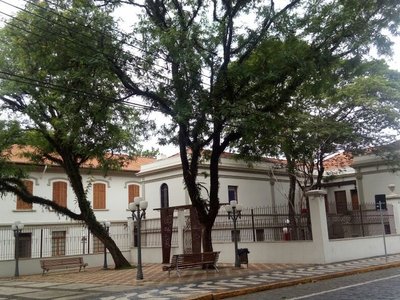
[241,61,400,237]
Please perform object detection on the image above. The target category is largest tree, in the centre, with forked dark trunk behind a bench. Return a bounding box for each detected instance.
[104,0,399,251]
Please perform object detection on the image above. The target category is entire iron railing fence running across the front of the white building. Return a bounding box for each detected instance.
[0,199,395,260]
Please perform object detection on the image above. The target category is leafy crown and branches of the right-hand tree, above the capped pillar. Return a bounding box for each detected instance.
[283,61,400,189]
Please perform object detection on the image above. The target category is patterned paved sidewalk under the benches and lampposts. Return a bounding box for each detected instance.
[0,254,400,300]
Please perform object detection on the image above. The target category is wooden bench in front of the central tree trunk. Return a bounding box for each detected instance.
[163,252,219,277]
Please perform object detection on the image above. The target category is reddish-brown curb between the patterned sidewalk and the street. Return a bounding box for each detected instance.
[188,261,400,300]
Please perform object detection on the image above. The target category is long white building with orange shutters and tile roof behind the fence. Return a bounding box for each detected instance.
[0,145,400,276]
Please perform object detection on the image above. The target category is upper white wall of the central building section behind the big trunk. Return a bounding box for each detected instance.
[138,157,296,218]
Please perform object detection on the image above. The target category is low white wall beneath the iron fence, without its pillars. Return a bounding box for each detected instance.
[136,235,400,264]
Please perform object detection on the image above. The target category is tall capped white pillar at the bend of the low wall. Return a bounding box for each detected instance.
[306,190,329,263]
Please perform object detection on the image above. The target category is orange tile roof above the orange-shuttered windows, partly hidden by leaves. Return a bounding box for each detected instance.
[5,145,156,172]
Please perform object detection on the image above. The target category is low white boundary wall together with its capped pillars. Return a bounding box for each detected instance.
[131,190,400,264]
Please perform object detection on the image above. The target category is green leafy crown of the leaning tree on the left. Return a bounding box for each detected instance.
[0,1,144,169]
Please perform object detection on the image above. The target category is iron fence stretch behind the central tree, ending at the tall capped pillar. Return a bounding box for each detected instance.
[141,205,311,247]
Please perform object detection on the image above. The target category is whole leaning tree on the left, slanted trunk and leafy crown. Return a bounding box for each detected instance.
[0,0,145,268]
